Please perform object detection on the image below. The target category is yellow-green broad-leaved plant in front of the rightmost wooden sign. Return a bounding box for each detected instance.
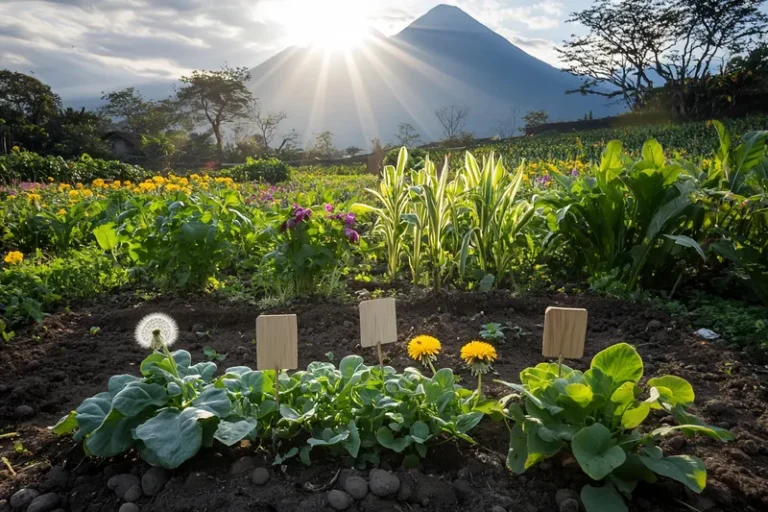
[503,343,733,512]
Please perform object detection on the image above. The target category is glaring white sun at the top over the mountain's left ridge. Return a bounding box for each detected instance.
[280,0,371,50]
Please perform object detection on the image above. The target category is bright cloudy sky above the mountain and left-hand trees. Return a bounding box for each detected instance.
[0,0,590,100]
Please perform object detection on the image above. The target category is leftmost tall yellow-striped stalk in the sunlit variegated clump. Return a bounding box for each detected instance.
[354,148,409,279]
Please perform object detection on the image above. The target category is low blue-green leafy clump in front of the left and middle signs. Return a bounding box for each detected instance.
[53,348,483,469]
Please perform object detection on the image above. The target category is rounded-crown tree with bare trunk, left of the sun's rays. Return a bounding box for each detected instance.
[176,67,254,159]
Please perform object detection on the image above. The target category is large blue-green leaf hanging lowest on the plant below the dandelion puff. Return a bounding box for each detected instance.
[134,407,213,469]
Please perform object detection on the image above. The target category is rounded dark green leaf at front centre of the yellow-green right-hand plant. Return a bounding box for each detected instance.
[571,423,626,480]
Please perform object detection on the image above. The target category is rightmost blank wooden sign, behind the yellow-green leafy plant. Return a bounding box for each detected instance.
[542,307,587,359]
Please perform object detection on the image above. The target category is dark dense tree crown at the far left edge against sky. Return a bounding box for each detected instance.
[0,69,61,126]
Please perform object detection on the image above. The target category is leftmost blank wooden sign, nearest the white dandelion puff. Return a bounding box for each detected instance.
[256,315,299,370]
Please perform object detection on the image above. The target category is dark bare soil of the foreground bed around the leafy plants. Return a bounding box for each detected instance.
[0,293,768,512]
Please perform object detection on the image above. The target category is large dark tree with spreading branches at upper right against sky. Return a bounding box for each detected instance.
[558,0,768,117]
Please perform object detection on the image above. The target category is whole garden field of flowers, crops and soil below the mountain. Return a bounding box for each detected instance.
[0,118,768,512]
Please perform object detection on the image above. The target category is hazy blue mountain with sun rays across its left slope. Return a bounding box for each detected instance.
[250,5,617,148]
